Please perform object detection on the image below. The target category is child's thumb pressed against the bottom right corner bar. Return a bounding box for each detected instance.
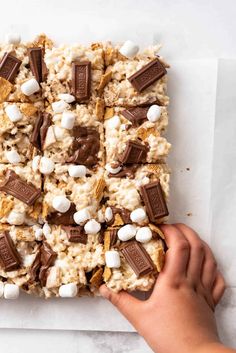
[99,284,144,326]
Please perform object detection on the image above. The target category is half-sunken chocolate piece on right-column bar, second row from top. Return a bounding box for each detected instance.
[119,140,148,164]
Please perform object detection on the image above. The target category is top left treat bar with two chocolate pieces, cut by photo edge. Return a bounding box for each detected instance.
[0,35,52,102]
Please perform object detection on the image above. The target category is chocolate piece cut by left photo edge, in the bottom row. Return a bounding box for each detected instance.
[0,231,21,271]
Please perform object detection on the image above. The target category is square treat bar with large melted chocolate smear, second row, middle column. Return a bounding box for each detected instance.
[42,102,104,168]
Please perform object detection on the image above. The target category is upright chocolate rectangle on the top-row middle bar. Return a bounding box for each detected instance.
[72,61,91,102]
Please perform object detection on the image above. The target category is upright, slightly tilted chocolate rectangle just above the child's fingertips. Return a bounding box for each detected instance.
[141,181,169,223]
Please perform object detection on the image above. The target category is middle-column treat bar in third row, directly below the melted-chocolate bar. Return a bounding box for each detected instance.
[43,163,105,225]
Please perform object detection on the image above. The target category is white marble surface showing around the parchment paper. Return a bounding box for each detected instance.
[0,0,236,353]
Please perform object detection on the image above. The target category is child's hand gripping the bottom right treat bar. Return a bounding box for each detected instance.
[100,224,225,353]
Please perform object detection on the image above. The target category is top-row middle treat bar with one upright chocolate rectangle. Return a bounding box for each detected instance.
[43,43,105,103]
